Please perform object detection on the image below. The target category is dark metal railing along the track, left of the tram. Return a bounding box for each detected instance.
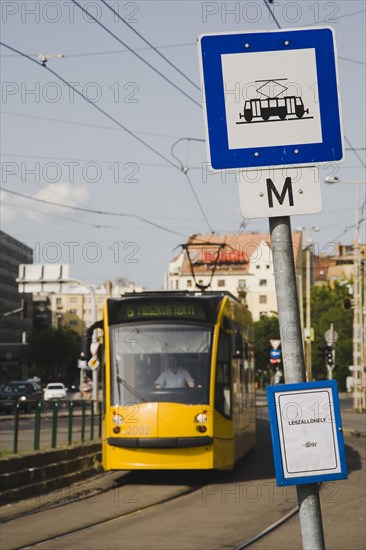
[0,400,102,454]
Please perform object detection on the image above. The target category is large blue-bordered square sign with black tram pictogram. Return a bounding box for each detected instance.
[199,27,344,169]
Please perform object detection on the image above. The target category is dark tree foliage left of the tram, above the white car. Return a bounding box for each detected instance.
[28,327,81,383]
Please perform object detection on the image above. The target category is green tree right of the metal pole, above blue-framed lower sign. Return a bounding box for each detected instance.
[311,284,353,390]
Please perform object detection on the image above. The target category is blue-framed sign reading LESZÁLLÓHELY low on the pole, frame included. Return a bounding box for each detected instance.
[266,380,348,486]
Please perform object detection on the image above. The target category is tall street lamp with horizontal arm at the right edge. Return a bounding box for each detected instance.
[324,176,366,412]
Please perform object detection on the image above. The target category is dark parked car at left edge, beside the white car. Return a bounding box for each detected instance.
[0,380,43,410]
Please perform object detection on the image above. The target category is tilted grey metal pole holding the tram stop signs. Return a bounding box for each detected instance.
[269,216,325,550]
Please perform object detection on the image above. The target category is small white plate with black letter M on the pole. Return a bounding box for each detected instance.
[238,166,322,218]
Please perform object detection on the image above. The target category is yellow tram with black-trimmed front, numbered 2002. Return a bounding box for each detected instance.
[98,291,255,470]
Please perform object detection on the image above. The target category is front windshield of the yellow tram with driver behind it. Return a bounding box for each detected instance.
[110,323,212,405]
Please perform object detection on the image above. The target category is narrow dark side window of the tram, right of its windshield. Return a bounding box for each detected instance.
[215,332,231,417]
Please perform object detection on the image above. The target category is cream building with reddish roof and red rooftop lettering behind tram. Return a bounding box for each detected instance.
[165,231,303,321]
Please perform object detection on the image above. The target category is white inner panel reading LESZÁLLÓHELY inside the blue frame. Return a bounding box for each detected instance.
[275,388,341,478]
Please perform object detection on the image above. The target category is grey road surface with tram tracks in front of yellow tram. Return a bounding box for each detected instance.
[0,409,366,550]
